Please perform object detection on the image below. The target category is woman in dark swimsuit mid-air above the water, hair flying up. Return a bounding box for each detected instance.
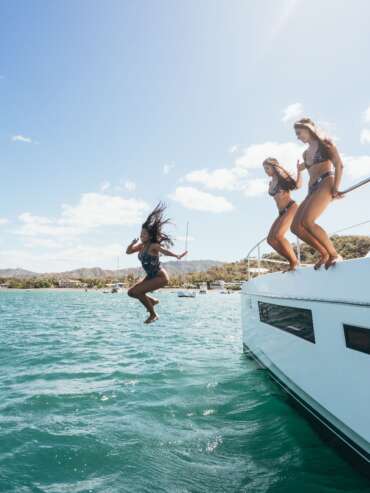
[126,203,187,324]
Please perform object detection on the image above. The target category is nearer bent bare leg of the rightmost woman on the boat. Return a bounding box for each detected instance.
[302,178,339,268]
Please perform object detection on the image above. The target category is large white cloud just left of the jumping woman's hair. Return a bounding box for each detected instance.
[17,193,148,239]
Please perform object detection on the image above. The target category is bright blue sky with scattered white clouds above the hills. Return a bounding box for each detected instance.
[0,0,370,272]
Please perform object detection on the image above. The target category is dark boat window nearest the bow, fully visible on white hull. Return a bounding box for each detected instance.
[258,301,315,343]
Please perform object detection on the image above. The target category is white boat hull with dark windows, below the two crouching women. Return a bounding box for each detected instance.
[242,258,370,465]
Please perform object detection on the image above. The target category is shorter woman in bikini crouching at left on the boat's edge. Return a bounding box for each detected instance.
[263,157,302,271]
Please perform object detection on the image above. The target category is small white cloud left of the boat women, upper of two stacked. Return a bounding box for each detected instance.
[185,168,248,190]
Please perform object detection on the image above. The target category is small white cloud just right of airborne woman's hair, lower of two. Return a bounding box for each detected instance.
[170,187,233,212]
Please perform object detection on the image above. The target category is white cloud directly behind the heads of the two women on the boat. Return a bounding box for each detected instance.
[235,142,305,171]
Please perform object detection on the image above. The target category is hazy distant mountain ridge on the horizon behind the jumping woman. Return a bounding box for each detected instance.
[0,260,224,280]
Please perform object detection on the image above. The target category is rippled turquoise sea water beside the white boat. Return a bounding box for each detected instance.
[0,291,370,493]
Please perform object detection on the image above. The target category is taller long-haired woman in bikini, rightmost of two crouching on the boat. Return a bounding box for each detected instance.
[291,118,343,270]
